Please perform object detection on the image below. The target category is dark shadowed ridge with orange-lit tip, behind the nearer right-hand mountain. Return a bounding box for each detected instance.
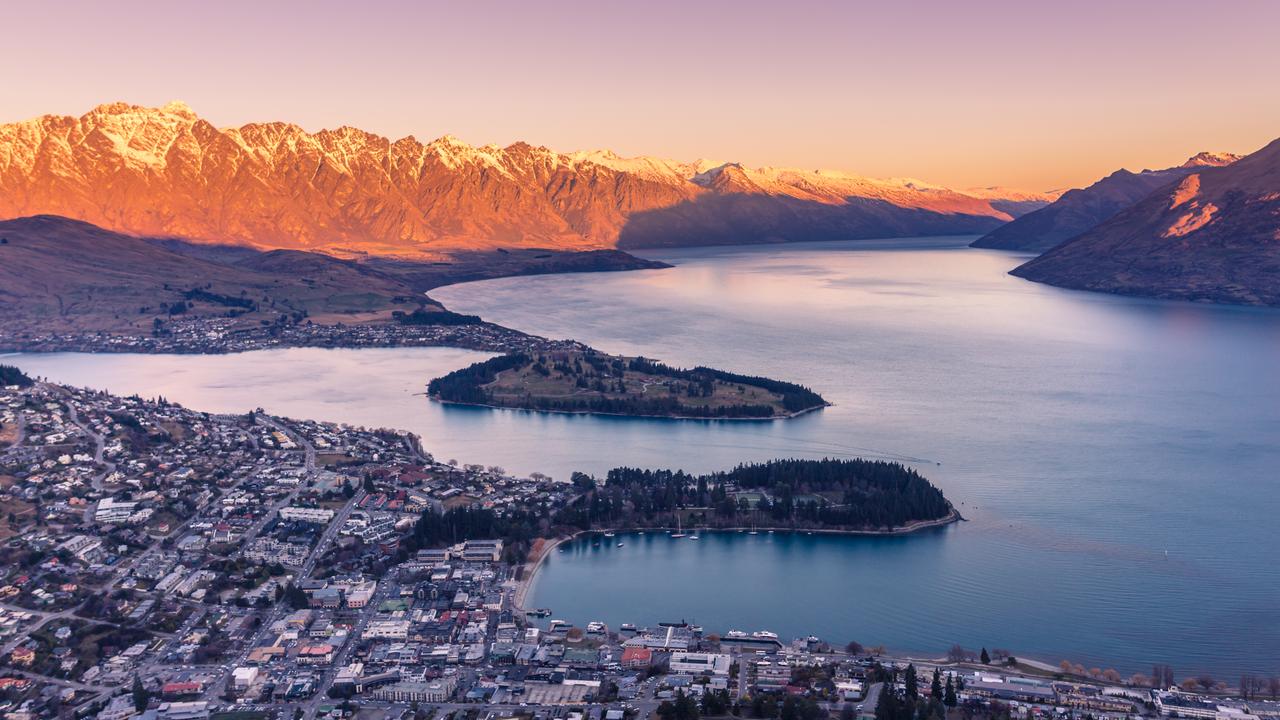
[973,152,1239,252]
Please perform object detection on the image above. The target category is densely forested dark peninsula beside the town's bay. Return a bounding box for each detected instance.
[557,459,961,534]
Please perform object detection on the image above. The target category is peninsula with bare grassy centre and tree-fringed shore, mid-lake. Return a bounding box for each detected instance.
[428,348,828,420]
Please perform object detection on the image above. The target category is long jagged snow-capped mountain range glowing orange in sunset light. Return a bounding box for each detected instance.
[0,102,1048,259]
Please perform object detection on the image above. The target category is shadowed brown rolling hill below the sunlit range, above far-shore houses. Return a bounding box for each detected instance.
[0,215,413,325]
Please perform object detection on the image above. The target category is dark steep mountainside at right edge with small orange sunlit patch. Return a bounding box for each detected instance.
[1014,140,1280,306]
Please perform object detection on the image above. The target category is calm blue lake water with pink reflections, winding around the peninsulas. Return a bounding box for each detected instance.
[9,238,1280,678]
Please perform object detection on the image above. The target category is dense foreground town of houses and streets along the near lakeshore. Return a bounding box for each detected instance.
[0,373,1280,720]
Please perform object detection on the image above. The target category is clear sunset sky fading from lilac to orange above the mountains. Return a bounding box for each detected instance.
[0,0,1280,190]
